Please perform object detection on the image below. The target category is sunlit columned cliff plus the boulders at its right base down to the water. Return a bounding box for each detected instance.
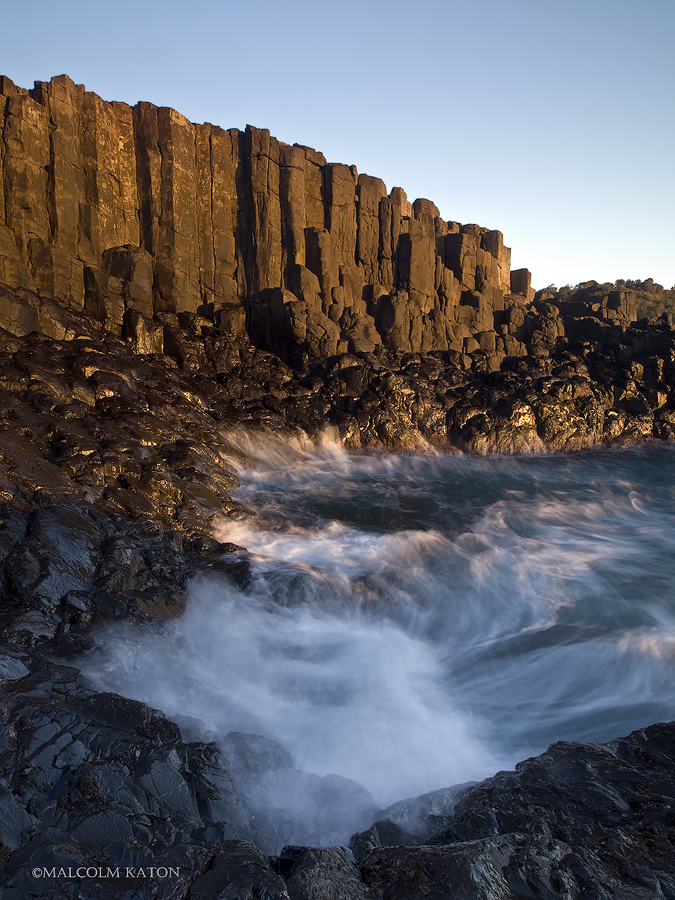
[0,76,675,451]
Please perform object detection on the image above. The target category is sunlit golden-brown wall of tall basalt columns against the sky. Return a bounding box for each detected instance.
[0,75,544,368]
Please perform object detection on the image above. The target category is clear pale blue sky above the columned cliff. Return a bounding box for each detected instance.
[0,0,675,287]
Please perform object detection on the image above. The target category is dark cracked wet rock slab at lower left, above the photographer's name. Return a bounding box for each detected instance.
[0,660,258,881]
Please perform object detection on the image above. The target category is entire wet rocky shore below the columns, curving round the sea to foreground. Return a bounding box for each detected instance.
[0,284,675,900]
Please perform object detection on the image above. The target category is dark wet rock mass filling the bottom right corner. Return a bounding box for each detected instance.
[356,723,675,900]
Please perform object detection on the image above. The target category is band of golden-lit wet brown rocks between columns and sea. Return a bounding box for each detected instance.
[0,268,674,458]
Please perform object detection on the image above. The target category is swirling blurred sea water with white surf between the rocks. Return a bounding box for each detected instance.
[83,438,675,806]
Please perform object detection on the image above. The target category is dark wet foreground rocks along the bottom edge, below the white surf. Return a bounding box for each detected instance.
[0,668,675,900]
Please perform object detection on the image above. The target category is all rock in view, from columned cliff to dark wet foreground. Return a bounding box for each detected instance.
[0,76,675,900]
